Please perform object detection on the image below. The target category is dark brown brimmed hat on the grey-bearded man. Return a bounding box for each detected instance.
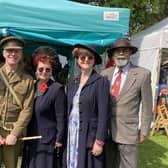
[107,38,138,56]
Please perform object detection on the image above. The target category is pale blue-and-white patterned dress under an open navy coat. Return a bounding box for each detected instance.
[67,86,82,168]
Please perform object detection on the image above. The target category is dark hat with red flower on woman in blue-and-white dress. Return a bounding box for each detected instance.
[73,44,102,64]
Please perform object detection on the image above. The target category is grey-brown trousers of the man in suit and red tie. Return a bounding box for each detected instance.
[105,141,138,168]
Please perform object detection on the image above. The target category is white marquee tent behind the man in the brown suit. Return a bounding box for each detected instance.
[132,18,168,108]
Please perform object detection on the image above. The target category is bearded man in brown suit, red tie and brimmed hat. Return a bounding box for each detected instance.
[102,38,153,168]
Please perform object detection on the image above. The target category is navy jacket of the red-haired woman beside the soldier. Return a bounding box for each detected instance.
[28,80,67,143]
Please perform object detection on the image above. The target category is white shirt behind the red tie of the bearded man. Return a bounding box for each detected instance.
[111,64,130,93]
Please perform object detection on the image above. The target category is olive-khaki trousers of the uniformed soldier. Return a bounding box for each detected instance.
[0,128,20,168]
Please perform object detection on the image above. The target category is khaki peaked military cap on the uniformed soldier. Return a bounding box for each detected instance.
[0,36,25,50]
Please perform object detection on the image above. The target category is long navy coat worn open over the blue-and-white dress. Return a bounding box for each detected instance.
[67,70,110,165]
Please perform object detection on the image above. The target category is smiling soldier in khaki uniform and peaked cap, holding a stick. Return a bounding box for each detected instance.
[0,36,34,168]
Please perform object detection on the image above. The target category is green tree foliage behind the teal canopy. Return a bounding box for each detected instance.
[71,0,168,34]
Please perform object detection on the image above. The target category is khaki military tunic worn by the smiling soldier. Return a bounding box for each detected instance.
[0,66,34,137]
